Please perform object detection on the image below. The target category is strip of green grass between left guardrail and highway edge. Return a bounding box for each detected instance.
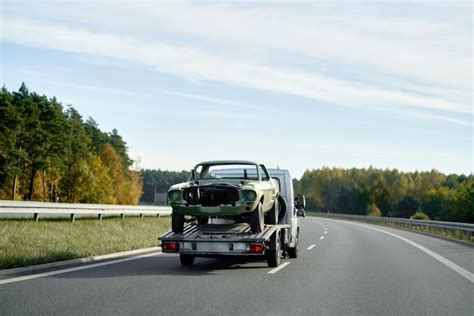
[0,217,171,269]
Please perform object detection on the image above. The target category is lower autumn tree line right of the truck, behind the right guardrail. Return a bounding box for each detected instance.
[294,168,474,223]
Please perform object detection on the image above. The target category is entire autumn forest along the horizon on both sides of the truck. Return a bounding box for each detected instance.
[0,84,474,223]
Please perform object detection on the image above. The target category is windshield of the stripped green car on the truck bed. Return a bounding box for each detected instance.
[194,163,258,180]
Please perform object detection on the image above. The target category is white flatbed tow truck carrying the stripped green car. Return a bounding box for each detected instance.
[158,169,304,267]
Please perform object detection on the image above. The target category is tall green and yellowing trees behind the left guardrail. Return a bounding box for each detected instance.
[0,83,142,204]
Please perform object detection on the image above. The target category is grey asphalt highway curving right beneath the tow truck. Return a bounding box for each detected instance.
[0,218,474,315]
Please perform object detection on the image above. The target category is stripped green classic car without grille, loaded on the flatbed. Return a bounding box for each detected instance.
[168,161,279,233]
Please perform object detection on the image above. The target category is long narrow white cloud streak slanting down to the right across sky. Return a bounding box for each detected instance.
[2,18,471,120]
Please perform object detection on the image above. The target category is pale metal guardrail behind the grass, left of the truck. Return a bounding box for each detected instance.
[0,200,171,222]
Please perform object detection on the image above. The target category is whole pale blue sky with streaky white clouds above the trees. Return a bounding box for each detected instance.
[0,0,474,177]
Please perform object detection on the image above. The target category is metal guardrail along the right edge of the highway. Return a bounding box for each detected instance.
[312,213,474,241]
